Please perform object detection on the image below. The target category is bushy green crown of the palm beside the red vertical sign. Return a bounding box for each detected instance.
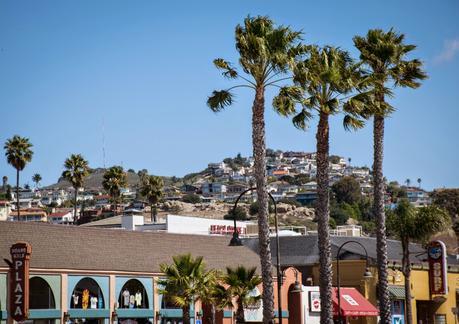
[387,199,450,242]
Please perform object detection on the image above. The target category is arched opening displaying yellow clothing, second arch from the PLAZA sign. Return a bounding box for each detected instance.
[70,277,105,309]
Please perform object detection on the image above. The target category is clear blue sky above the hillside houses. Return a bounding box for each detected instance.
[0,0,459,189]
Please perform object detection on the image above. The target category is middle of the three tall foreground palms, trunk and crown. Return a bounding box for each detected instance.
[274,46,364,324]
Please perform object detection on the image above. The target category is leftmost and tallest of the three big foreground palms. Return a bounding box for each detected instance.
[207,16,304,323]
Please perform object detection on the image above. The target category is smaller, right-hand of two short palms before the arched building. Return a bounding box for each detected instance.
[223,266,264,323]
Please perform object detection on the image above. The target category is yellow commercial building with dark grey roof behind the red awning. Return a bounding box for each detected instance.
[243,235,459,324]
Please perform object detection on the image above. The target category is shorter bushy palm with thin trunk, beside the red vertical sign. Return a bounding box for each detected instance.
[387,199,450,324]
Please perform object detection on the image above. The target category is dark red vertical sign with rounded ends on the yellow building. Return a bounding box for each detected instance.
[427,241,448,295]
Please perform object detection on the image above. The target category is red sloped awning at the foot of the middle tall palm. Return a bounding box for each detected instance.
[333,288,379,317]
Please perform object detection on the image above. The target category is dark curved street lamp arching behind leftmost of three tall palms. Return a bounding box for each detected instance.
[229,187,282,324]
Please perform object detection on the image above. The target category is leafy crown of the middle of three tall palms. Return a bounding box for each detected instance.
[273,46,366,129]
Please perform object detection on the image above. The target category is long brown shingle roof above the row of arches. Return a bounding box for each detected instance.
[0,222,260,273]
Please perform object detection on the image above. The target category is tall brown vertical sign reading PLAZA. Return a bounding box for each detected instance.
[9,242,32,322]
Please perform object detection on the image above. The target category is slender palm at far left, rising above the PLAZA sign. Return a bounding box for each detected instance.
[3,135,33,220]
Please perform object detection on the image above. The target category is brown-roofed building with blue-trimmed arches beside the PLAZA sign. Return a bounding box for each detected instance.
[0,222,301,324]
